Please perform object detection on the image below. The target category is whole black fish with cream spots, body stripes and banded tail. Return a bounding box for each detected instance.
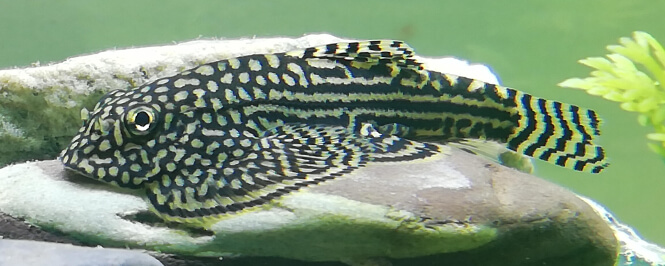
[60,40,608,227]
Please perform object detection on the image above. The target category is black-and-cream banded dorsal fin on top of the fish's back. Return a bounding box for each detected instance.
[286,40,423,70]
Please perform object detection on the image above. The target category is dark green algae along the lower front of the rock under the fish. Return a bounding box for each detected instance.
[210,215,495,261]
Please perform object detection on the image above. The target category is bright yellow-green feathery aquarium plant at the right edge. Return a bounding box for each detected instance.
[559,31,665,160]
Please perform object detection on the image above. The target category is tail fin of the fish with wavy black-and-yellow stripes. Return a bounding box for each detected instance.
[508,91,609,173]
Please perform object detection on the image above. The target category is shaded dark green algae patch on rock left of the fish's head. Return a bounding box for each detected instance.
[0,81,104,167]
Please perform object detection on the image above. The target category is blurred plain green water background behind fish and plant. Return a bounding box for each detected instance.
[0,0,665,245]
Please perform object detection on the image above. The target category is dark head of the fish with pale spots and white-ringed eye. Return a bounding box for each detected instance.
[59,90,162,188]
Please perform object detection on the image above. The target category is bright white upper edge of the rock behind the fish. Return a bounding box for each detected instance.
[0,34,497,96]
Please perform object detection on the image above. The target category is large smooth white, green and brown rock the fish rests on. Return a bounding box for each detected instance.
[0,148,617,265]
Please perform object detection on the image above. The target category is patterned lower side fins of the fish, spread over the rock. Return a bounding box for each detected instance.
[147,124,439,227]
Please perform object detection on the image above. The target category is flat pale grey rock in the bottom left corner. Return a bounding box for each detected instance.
[0,239,163,266]
